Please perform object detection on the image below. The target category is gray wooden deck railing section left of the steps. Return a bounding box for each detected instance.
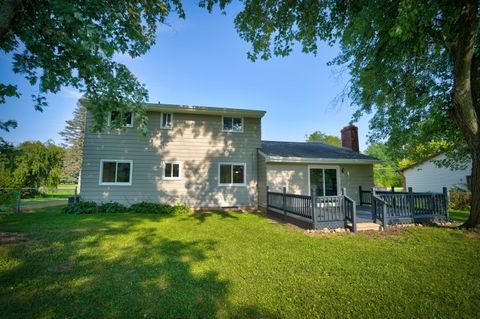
[267,187,356,231]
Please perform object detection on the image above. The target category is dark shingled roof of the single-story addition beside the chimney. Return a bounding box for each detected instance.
[260,141,380,164]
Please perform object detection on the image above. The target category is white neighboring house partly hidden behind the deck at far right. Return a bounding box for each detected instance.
[402,153,472,192]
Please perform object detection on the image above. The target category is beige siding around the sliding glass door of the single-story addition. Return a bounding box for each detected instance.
[259,162,374,205]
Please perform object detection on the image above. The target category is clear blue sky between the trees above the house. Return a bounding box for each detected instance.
[0,2,368,150]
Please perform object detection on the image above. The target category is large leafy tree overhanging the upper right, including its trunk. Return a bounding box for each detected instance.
[200,0,480,227]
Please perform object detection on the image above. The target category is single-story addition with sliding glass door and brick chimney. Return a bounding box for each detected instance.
[258,139,379,208]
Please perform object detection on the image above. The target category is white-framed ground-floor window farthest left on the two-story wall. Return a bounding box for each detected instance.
[99,160,133,186]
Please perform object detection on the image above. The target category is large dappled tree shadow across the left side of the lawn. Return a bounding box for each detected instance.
[0,211,275,318]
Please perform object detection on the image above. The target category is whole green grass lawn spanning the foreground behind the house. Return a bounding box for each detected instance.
[0,208,480,318]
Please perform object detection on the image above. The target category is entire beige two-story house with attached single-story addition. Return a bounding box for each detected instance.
[80,104,378,208]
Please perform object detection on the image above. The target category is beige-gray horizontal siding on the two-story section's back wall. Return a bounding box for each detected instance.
[80,112,261,207]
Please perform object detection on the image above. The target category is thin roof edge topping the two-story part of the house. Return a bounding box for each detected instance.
[147,103,266,118]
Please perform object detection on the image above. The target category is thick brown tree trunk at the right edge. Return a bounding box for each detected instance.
[451,0,480,228]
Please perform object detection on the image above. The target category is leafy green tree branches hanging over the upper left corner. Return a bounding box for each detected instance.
[0,0,185,130]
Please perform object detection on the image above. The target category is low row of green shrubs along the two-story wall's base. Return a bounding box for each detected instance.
[62,201,190,215]
